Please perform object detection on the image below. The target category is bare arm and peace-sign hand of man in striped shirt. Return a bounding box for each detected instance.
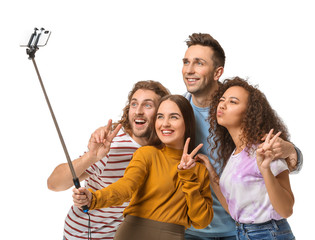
[47,120,121,191]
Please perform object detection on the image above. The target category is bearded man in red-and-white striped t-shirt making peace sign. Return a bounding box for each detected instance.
[47,81,169,239]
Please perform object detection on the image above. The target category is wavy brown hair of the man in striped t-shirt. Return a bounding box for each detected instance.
[113,80,170,134]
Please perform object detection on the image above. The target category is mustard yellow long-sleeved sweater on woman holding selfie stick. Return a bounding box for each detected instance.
[90,146,213,228]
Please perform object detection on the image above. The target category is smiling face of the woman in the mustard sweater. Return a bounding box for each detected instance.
[155,100,185,149]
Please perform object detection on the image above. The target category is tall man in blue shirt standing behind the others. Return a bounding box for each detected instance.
[182,33,302,240]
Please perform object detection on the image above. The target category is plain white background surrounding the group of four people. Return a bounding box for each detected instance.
[0,0,315,239]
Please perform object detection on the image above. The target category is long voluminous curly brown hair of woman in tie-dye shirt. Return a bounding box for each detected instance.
[208,77,289,171]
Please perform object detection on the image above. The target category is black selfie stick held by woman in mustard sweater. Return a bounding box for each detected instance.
[26,28,89,213]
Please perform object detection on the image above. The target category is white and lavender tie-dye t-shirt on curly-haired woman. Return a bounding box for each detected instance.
[220,147,288,223]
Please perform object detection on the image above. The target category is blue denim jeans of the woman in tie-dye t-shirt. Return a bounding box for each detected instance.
[236,219,295,240]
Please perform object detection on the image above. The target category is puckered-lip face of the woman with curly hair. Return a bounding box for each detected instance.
[217,86,249,131]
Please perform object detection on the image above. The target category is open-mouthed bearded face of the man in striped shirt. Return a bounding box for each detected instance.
[128,89,160,144]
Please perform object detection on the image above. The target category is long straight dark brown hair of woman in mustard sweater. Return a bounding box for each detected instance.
[148,94,196,153]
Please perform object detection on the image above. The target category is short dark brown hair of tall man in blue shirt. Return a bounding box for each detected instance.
[186,33,225,68]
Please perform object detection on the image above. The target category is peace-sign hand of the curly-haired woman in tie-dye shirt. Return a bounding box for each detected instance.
[256,129,281,171]
